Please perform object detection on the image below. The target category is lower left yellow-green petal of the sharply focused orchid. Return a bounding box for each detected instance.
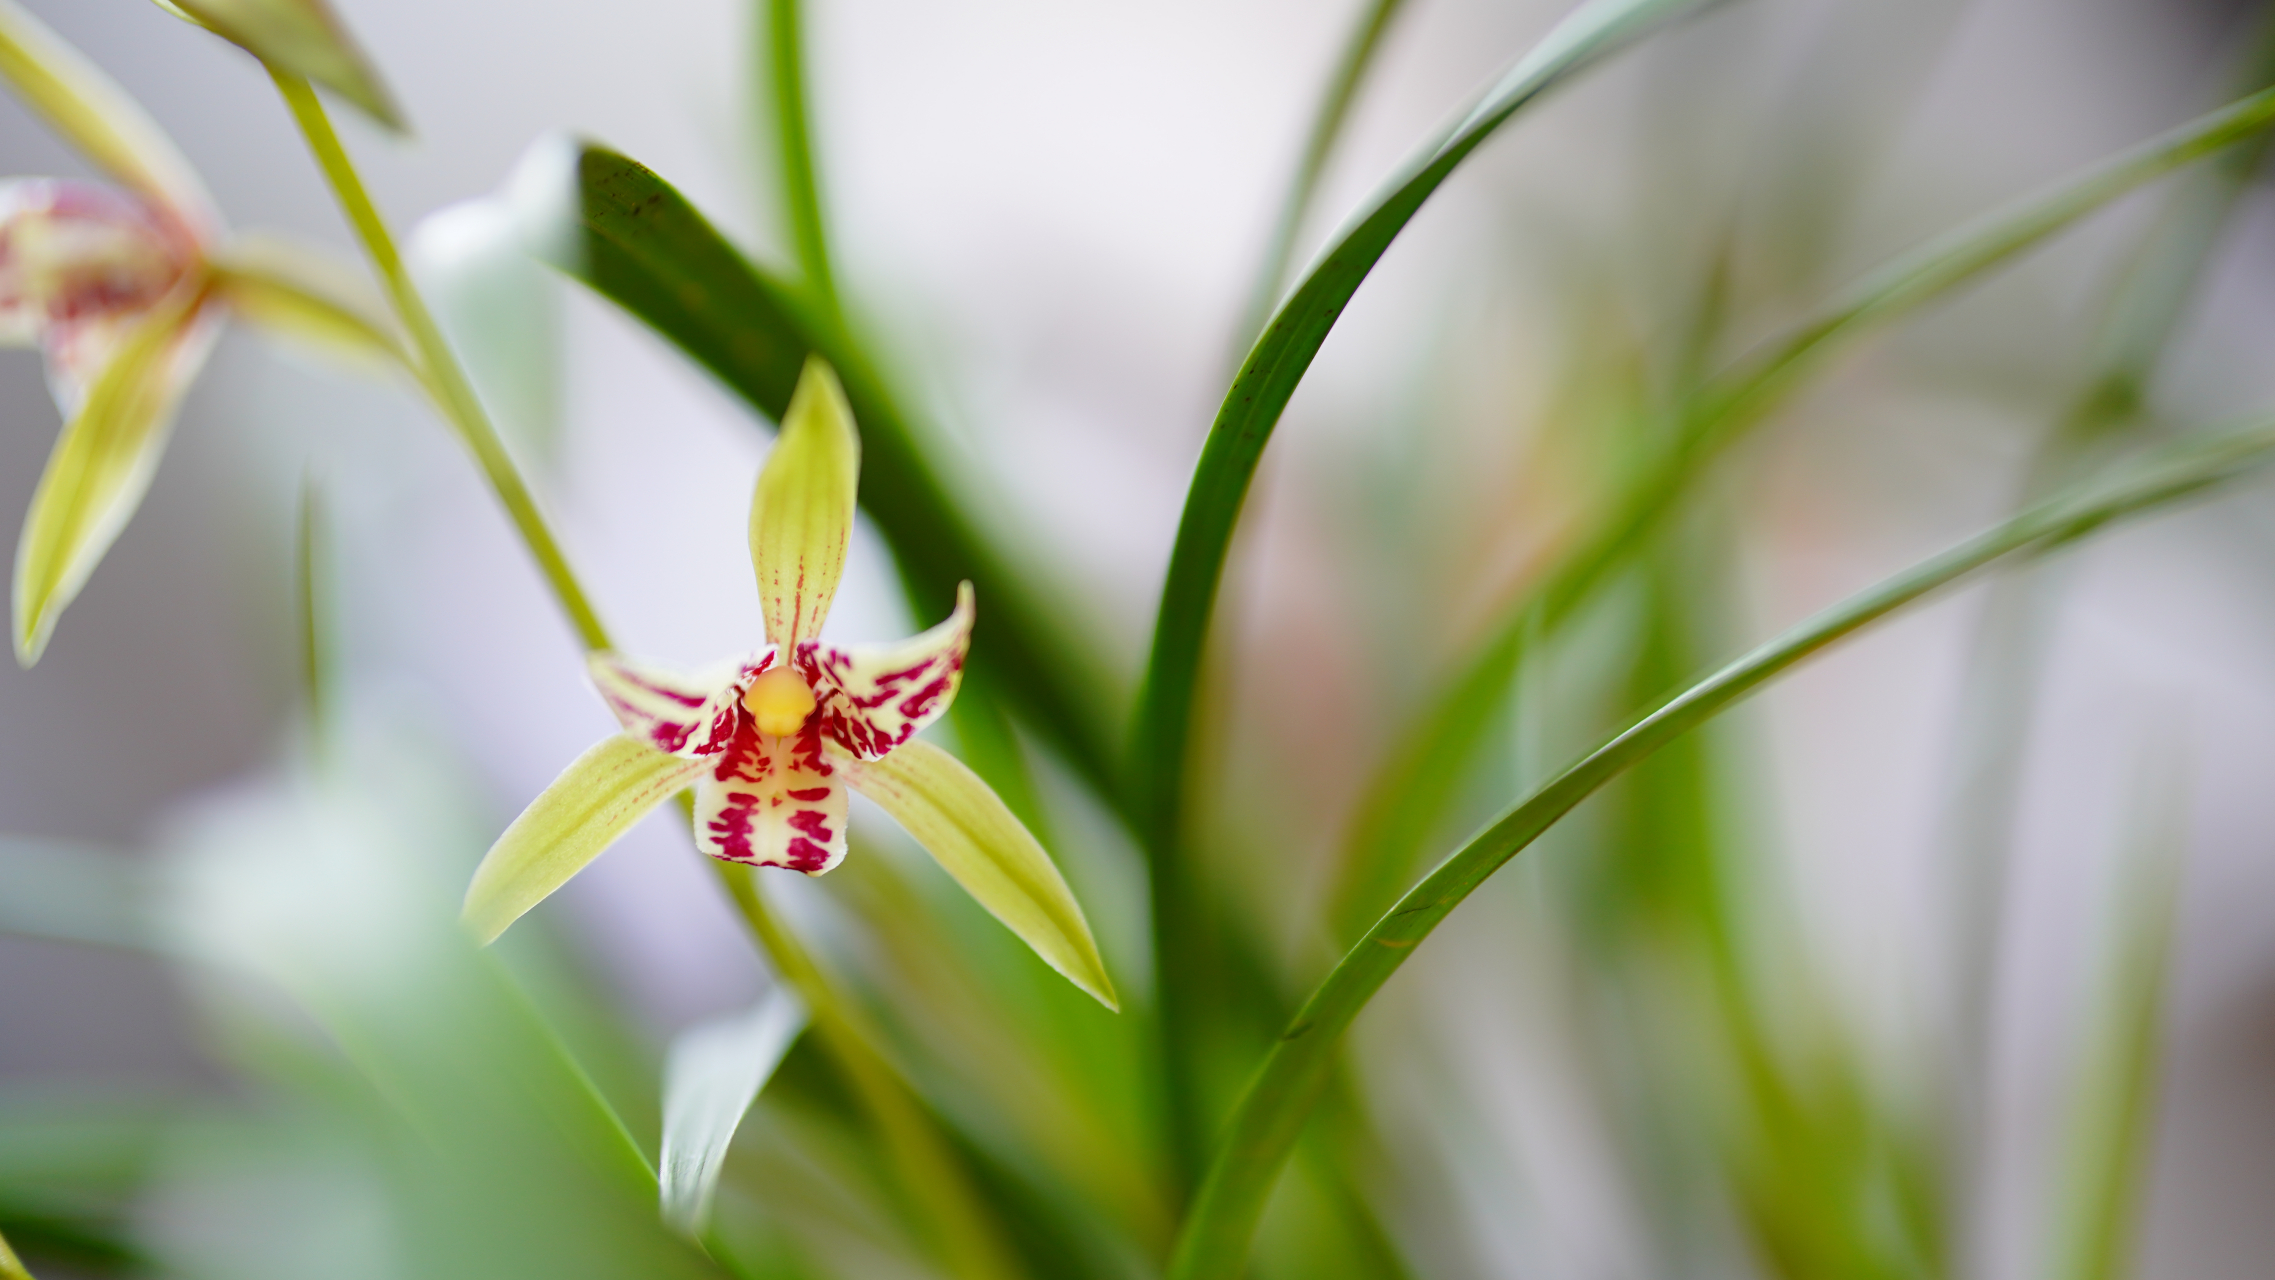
[460,734,703,946]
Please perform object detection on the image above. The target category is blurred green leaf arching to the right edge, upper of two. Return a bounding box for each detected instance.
[1335,80,2275,937]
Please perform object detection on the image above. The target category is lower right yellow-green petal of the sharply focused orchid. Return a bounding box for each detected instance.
[844,741,1122,1009]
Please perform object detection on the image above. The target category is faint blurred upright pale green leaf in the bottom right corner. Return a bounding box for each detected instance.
[2052,750,2189,1280]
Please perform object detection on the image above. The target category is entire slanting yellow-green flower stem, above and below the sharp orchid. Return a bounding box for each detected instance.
[275,68,1017,1280]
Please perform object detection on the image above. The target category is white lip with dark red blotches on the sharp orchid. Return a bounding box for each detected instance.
[696,716,846,875]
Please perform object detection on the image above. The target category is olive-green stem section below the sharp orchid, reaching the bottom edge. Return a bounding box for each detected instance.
[712,859,1019,1280]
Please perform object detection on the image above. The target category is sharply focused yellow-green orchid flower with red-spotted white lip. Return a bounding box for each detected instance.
[466,357,1115,1007]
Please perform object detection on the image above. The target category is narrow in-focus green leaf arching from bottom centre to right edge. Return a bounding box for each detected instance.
[1169,416,2275,1280]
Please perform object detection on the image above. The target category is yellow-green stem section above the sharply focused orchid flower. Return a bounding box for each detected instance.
[268,68,612,648]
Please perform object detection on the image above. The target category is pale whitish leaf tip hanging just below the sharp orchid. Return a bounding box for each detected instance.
[657,987,805,1237]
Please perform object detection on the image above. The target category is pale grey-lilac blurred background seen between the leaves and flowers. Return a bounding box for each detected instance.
[0,0,2275,1280]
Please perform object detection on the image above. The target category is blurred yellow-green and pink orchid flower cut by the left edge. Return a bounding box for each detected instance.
[0,0,400,666]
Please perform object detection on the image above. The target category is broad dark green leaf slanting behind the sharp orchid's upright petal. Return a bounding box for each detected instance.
[548,146,1119,798]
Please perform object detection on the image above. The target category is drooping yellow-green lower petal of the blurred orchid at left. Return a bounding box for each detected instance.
[16,286,218,666]
